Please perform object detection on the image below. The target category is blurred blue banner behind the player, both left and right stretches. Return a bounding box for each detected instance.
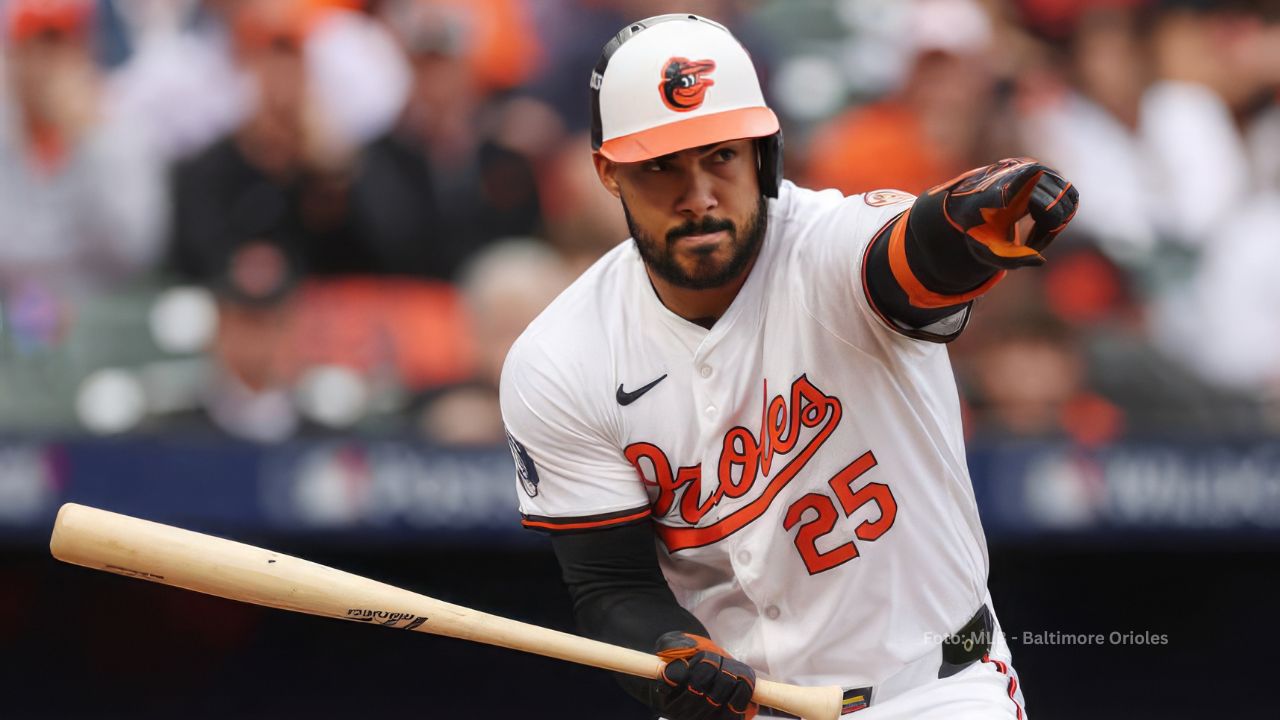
[0,438,1280,544]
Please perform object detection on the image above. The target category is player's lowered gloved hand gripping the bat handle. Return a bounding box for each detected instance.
[657,630,759,720]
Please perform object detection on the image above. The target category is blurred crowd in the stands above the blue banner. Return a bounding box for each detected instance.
[0,0,1280,445]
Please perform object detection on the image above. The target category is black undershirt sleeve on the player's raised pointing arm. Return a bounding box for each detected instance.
[864,202,996,342]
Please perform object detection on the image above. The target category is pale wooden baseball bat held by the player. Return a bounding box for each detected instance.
[49,502,841,720]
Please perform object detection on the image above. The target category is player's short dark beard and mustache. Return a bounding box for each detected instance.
[622,195,769,290]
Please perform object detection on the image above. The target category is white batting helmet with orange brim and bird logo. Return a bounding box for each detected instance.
[591,13,782,197]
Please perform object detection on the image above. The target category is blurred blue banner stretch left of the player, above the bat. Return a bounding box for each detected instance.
[0,439,530,543]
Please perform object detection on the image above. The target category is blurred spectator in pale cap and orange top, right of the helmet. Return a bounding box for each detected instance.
[808,0,997,195]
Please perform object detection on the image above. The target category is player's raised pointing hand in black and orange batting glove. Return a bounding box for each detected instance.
[916,158,1080,270]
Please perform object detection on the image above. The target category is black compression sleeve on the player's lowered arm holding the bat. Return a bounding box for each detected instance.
[552,523,707,708]
